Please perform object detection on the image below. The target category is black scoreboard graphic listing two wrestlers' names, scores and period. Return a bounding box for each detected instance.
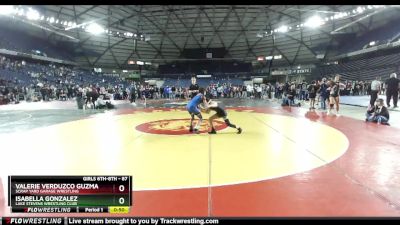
[8,176,133,213]
